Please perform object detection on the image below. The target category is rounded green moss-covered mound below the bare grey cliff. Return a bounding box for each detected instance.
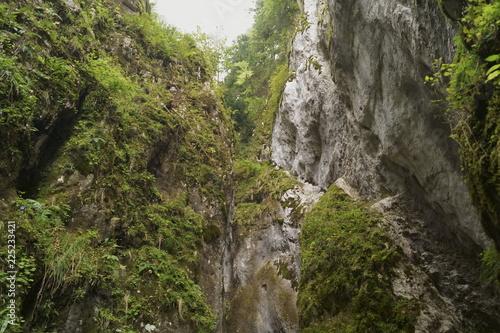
[298,186,419,332]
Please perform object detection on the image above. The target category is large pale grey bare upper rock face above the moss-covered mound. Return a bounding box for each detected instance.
[272,0,488,248]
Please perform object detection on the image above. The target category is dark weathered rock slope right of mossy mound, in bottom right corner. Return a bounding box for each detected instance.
[371,196,500,332]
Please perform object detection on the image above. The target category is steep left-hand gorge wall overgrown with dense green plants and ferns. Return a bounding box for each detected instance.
[0,0,232,332]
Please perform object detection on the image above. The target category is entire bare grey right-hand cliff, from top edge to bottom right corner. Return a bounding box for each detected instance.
[271,0,498,332]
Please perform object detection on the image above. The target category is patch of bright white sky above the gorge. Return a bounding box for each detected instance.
[151,0,255,41]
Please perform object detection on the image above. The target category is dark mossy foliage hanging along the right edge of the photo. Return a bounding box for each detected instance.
[430,0,500,256]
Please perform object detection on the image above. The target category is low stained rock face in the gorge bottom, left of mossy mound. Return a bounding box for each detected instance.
[222,184,322,333]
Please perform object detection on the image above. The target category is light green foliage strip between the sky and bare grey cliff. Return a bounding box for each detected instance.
[224,0,300,155]
